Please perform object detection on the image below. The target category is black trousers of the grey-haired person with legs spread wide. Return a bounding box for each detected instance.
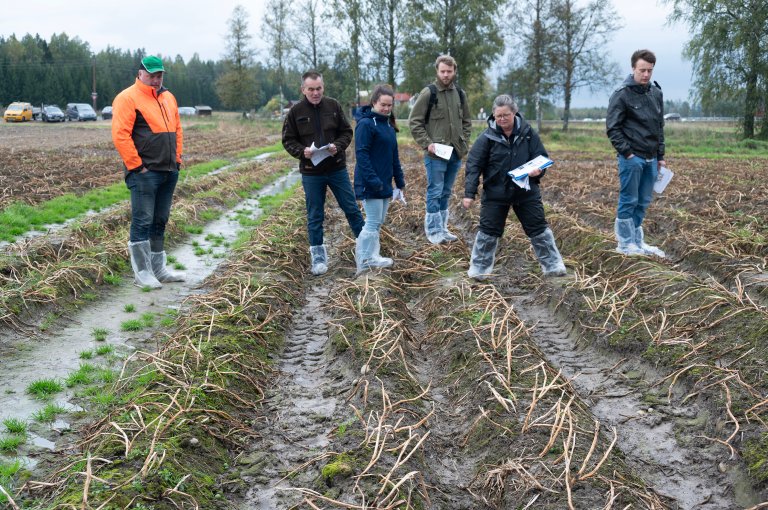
[480,184,549,237]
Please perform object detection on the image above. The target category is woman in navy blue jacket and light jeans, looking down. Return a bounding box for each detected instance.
[355,85,405,274]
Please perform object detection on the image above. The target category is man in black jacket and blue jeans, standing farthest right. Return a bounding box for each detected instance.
[606,50,665,257]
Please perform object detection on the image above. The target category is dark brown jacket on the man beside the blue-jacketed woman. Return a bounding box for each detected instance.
[283,97,353,175]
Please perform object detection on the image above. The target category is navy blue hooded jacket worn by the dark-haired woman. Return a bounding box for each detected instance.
[355,105,405,200]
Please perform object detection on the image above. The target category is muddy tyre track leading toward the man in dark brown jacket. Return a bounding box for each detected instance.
[239,281,348,510]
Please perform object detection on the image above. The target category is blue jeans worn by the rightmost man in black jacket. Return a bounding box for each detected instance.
[616,155,658,227]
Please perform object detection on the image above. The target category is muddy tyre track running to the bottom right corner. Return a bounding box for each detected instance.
[500,289,758,510]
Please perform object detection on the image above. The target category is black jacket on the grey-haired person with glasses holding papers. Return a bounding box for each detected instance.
[464,112,549,199]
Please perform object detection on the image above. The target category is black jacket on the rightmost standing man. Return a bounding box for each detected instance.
[605,75,665,160]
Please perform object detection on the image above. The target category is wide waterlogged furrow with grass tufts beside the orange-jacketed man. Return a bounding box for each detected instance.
[0,172,300,466]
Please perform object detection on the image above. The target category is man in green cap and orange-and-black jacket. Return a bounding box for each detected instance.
[112,56,184,289]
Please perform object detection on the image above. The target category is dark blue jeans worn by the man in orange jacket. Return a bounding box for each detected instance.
[125,170,179,252]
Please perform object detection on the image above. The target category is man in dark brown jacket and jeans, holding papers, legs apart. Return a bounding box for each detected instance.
[283,71,365,275]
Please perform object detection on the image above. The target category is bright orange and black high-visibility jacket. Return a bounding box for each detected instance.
[112,78,183,172]
